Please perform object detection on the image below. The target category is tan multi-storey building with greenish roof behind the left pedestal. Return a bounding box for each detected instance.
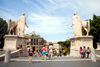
[25,31,46,52]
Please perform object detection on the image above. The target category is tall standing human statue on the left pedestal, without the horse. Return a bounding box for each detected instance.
[16,12,28,36]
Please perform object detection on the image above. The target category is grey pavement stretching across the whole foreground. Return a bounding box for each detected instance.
[0,57,100,67]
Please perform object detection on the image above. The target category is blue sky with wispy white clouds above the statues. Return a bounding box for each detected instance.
[0,0,100,42]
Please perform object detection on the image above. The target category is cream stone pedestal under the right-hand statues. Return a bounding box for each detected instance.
[70,36,93,57]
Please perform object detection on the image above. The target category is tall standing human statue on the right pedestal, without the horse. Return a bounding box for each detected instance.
[71,12,82,37]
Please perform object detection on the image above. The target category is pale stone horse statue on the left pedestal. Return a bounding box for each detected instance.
[7,19,17,35]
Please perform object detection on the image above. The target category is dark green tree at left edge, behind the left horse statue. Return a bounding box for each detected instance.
[0,18,7,48]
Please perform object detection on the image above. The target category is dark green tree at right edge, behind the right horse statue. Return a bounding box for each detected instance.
[89,14,100,49]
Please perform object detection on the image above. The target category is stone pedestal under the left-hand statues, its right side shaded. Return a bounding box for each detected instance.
[4,35,27,56]
